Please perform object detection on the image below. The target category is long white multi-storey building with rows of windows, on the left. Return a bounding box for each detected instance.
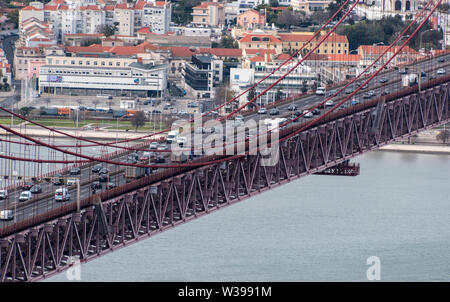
[39,53,168,97]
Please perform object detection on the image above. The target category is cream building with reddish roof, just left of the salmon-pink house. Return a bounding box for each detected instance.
[191,2,225,27]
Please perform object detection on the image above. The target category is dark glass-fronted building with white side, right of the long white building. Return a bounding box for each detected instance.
[184,54,223,99]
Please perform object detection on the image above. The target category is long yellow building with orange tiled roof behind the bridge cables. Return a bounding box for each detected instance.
[278,32,349,55]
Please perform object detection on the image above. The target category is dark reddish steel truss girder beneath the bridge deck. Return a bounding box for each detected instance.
[0,83,450,281]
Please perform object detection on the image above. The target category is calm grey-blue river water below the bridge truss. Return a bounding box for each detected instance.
[42,152,450,281]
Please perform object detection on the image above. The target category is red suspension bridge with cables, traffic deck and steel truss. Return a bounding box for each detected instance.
[0,0,450,281]
